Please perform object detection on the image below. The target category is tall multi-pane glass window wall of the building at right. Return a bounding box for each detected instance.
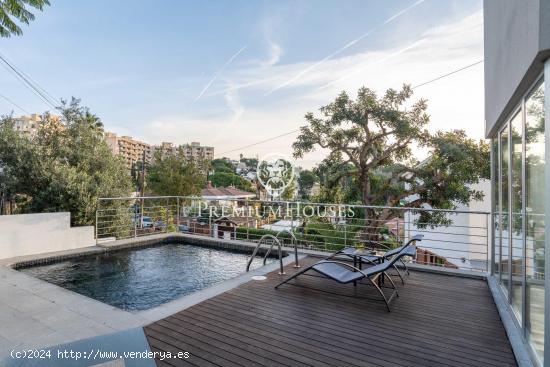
[491,77,546,366]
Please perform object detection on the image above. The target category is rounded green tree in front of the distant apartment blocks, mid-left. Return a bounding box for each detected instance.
[146,151,205,196]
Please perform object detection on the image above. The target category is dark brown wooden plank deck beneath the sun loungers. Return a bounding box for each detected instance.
[145,259,516,367]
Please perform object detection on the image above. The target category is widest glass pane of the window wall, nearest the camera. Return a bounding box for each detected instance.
[525,79,545,365]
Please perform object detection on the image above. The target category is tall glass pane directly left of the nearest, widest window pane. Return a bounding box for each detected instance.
[510,112,523,325]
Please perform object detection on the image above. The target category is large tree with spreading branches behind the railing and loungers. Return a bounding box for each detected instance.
[293,85,490,239]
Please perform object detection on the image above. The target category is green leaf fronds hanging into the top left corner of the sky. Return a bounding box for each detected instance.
[0,0,50,37]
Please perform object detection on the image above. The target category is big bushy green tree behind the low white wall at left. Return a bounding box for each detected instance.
[0,98,132,229]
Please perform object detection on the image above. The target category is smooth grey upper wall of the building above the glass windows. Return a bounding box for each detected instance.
[484,0,550,137]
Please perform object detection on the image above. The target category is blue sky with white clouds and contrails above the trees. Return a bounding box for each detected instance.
[0,0,484,167]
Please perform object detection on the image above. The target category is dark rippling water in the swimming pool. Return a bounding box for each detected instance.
[20,244,270,311]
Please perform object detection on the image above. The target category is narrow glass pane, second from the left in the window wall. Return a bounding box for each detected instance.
[498,126,510,294]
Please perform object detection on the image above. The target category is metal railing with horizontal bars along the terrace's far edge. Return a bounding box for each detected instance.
[96,196,491,272]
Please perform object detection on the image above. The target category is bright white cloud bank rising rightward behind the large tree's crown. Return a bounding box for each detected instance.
[140,10,484,166]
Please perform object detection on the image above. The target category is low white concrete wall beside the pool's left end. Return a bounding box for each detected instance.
[0,213,95,259]
